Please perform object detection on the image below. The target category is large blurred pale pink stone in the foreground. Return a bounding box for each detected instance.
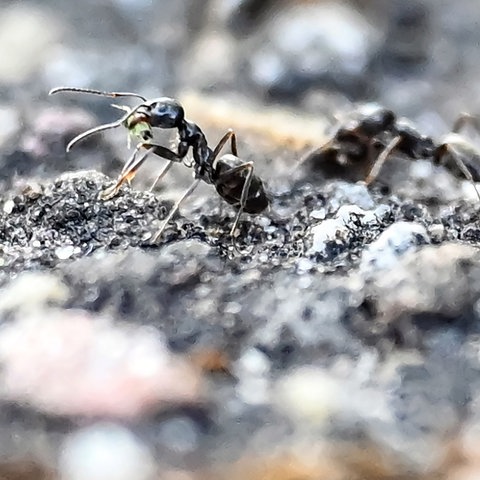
[0,310,201,418]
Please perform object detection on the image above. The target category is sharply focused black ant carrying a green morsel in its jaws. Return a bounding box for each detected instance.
[50,87,270,243]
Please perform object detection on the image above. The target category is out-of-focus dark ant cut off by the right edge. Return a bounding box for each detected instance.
[302,104,480,199]
